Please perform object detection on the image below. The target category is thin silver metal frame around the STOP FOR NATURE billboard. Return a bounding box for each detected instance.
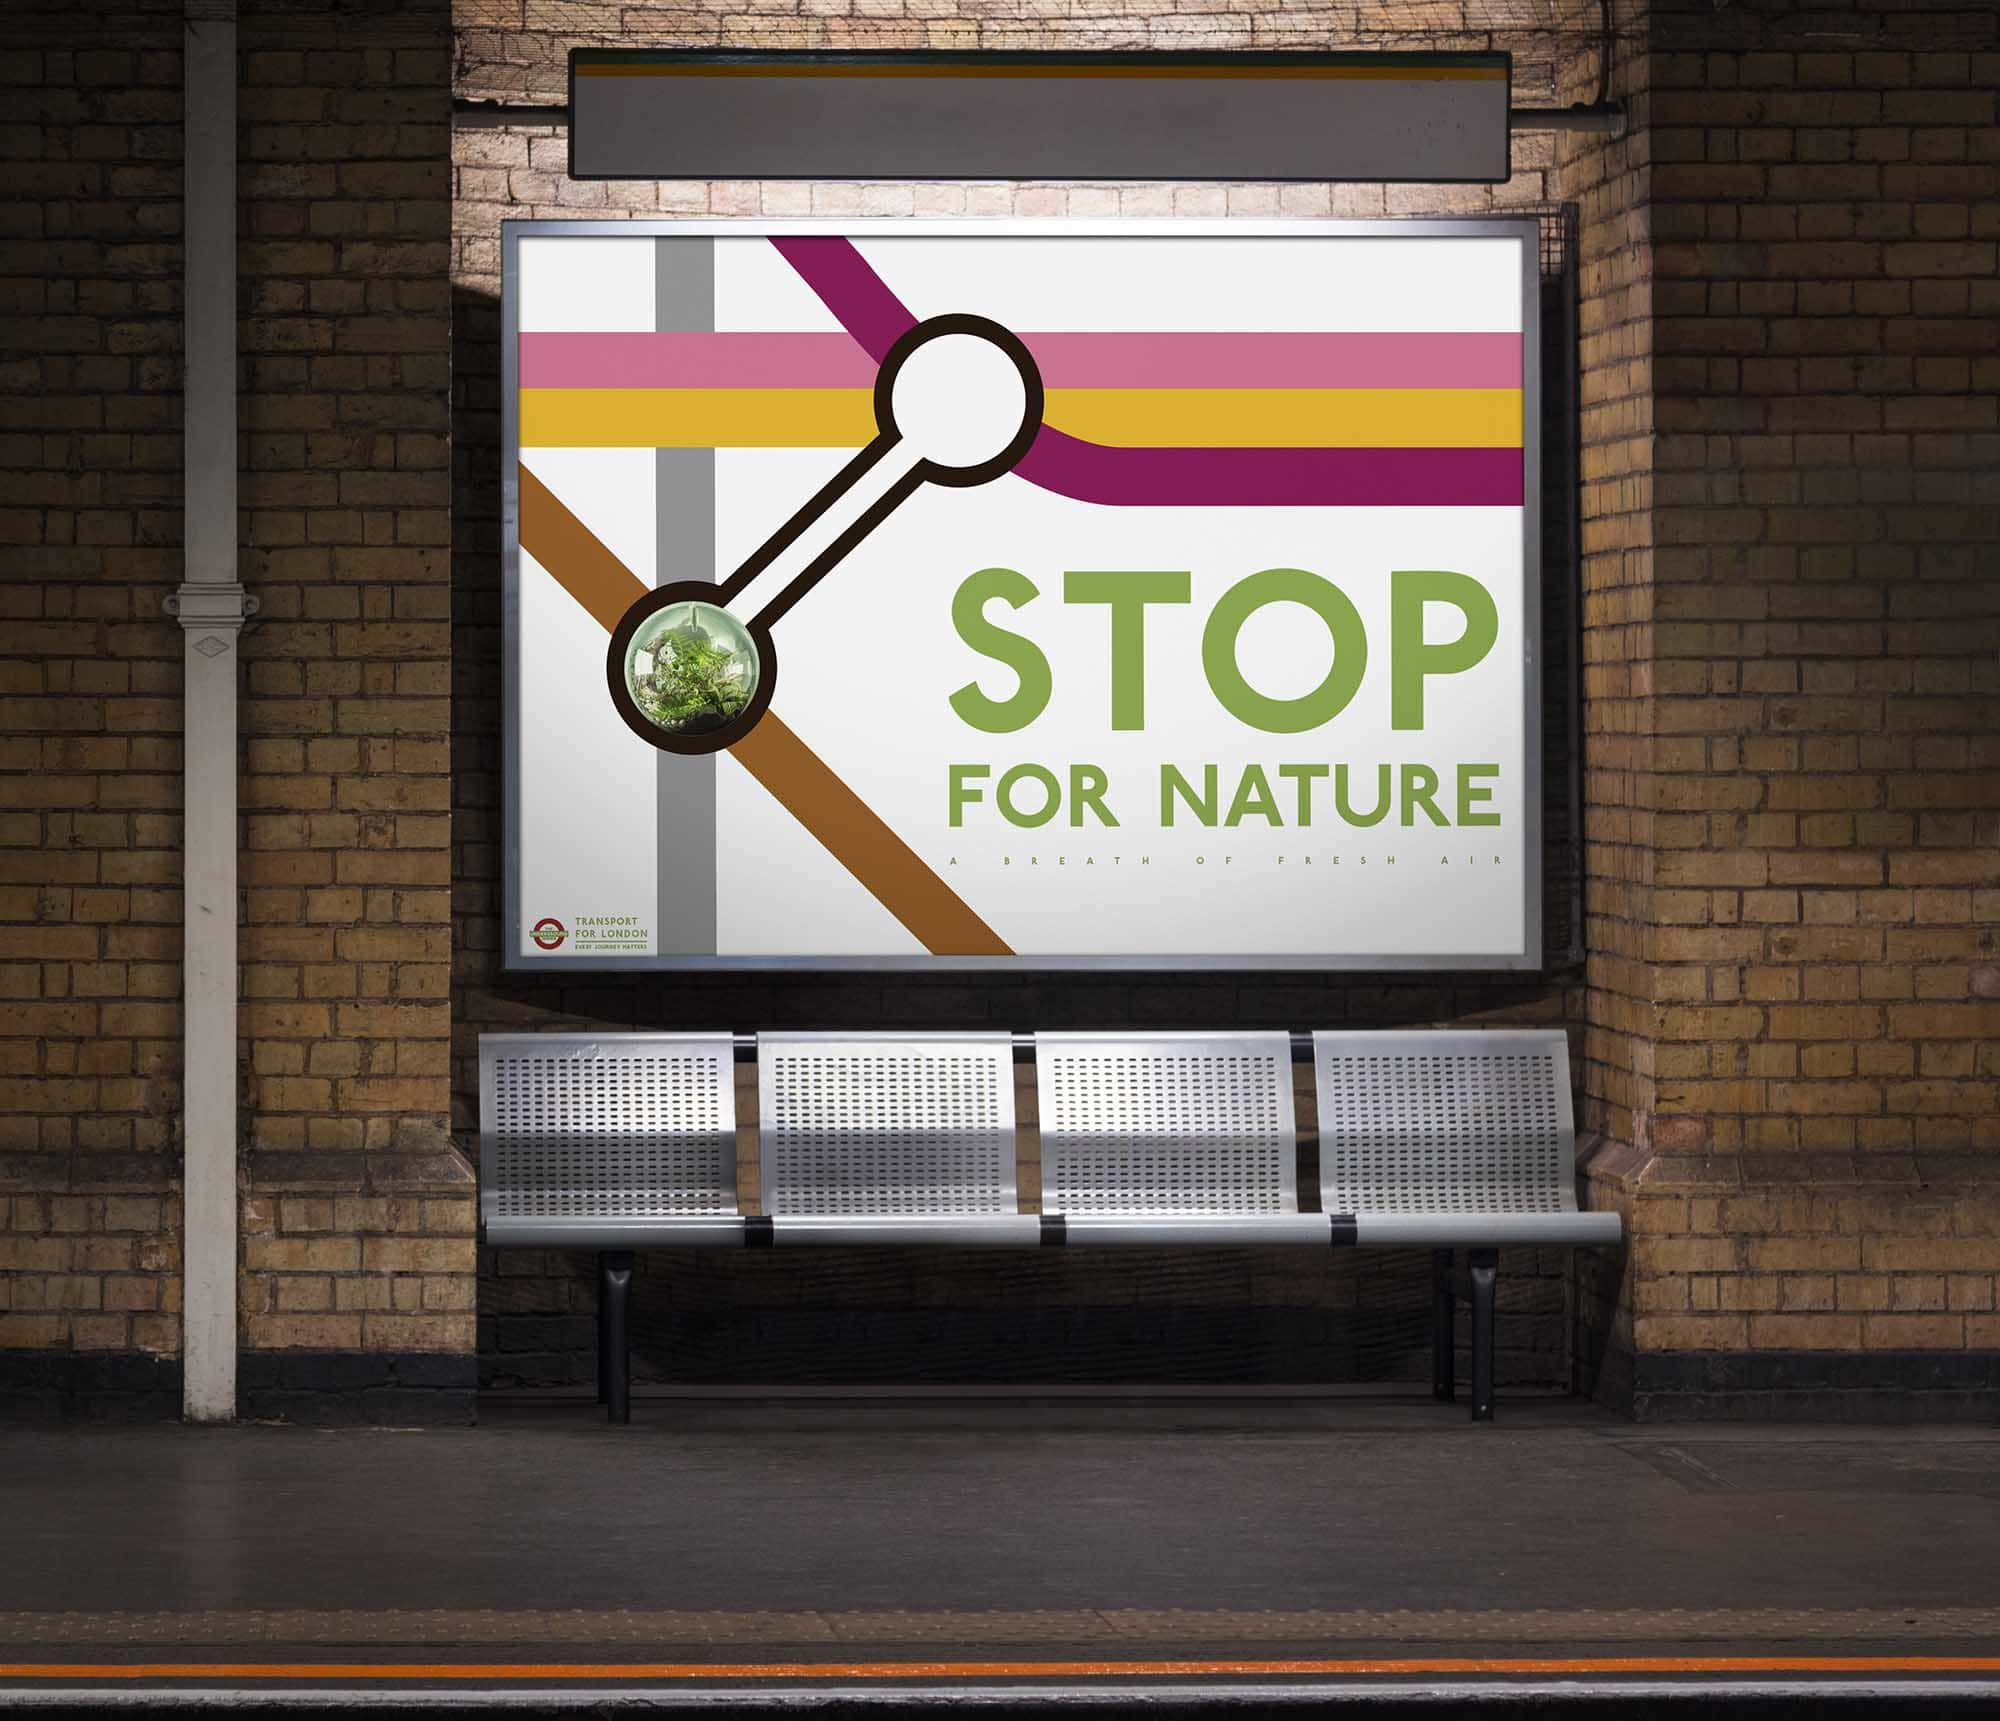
[500,214,1548,975]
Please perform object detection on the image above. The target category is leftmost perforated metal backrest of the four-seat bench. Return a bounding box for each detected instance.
[480,1035,736,1223]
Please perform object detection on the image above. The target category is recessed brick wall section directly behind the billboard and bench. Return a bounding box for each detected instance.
[454,0,1600,1387]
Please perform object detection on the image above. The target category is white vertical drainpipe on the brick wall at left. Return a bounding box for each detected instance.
[166,0,256,1423]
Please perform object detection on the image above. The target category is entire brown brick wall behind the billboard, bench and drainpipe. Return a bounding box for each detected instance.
[0,0,2000,1415]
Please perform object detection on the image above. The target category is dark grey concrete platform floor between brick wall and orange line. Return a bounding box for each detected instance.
[0,1399,2000,1657]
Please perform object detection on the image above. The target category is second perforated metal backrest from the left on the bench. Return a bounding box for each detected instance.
[756,1033,1018,1215]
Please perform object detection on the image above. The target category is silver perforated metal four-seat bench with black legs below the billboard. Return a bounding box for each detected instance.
[480,1031,1622,1421]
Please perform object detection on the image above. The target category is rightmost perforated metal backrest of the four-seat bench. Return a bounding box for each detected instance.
[1312,1029,1576,1213]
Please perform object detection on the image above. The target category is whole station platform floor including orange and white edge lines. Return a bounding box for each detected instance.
[0,1397,2000,1717]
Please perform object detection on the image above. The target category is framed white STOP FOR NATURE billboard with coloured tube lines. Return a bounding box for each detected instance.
[504,218,1542,969]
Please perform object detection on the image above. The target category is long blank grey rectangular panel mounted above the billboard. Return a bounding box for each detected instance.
[570,48,1512,184]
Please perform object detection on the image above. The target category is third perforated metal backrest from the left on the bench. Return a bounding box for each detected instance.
[1034,1033,1298,1215]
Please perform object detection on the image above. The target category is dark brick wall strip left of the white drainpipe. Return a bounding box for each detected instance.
[0,8,180,1391]
